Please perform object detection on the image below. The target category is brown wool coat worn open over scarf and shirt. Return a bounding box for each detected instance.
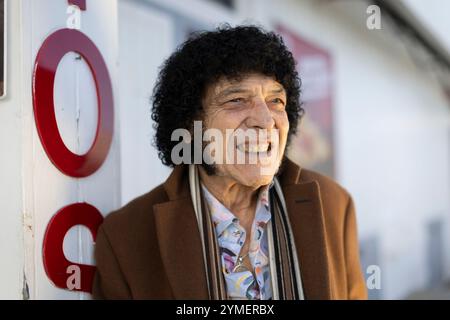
[93,158,367,299]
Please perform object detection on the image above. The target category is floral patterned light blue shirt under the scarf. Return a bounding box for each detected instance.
[202,185,272,300]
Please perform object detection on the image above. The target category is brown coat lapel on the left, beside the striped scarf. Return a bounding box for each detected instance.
[153,166,208,299]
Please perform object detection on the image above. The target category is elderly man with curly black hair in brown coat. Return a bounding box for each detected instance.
[93,26,367,300]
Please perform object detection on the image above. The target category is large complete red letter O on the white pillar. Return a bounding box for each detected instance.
[32,29,114,178]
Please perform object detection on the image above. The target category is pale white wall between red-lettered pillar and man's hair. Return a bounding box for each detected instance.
[119,1,174,204]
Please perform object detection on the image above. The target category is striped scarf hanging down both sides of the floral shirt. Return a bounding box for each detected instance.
[189,164,304,300]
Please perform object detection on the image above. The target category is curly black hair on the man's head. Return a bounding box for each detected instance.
[152,25,304,167]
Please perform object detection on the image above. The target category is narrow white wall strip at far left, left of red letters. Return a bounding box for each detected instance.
[0,1,24,299]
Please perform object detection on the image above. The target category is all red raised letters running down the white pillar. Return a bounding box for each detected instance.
[33,0,114,292]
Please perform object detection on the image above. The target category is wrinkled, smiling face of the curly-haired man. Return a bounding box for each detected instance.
[203,74,289,188]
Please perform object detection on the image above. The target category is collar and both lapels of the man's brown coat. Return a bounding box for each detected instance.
[153,158,331,299]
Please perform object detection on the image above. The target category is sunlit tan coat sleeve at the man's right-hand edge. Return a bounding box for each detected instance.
[344,196,367,300]
